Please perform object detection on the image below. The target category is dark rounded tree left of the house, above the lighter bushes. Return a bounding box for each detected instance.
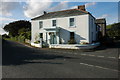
[3,20,31,37]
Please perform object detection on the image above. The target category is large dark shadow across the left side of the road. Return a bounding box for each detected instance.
[2,41,72,65]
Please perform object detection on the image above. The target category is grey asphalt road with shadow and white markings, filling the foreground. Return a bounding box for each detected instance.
[2,41,119,78]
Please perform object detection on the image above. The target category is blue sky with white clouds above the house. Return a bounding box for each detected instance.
[0,0,118,34]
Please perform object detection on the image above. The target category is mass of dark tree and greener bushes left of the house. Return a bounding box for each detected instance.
[3,20,31,42]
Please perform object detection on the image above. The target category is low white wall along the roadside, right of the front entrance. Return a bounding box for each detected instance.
[49,43,100,49]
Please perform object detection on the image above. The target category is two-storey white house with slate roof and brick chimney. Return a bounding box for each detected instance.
[31,5,97,45]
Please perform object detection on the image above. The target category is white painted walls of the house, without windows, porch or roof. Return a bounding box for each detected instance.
[31,14,95,44]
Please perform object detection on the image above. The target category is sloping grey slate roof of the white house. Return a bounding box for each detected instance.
[31,9,89,20]
